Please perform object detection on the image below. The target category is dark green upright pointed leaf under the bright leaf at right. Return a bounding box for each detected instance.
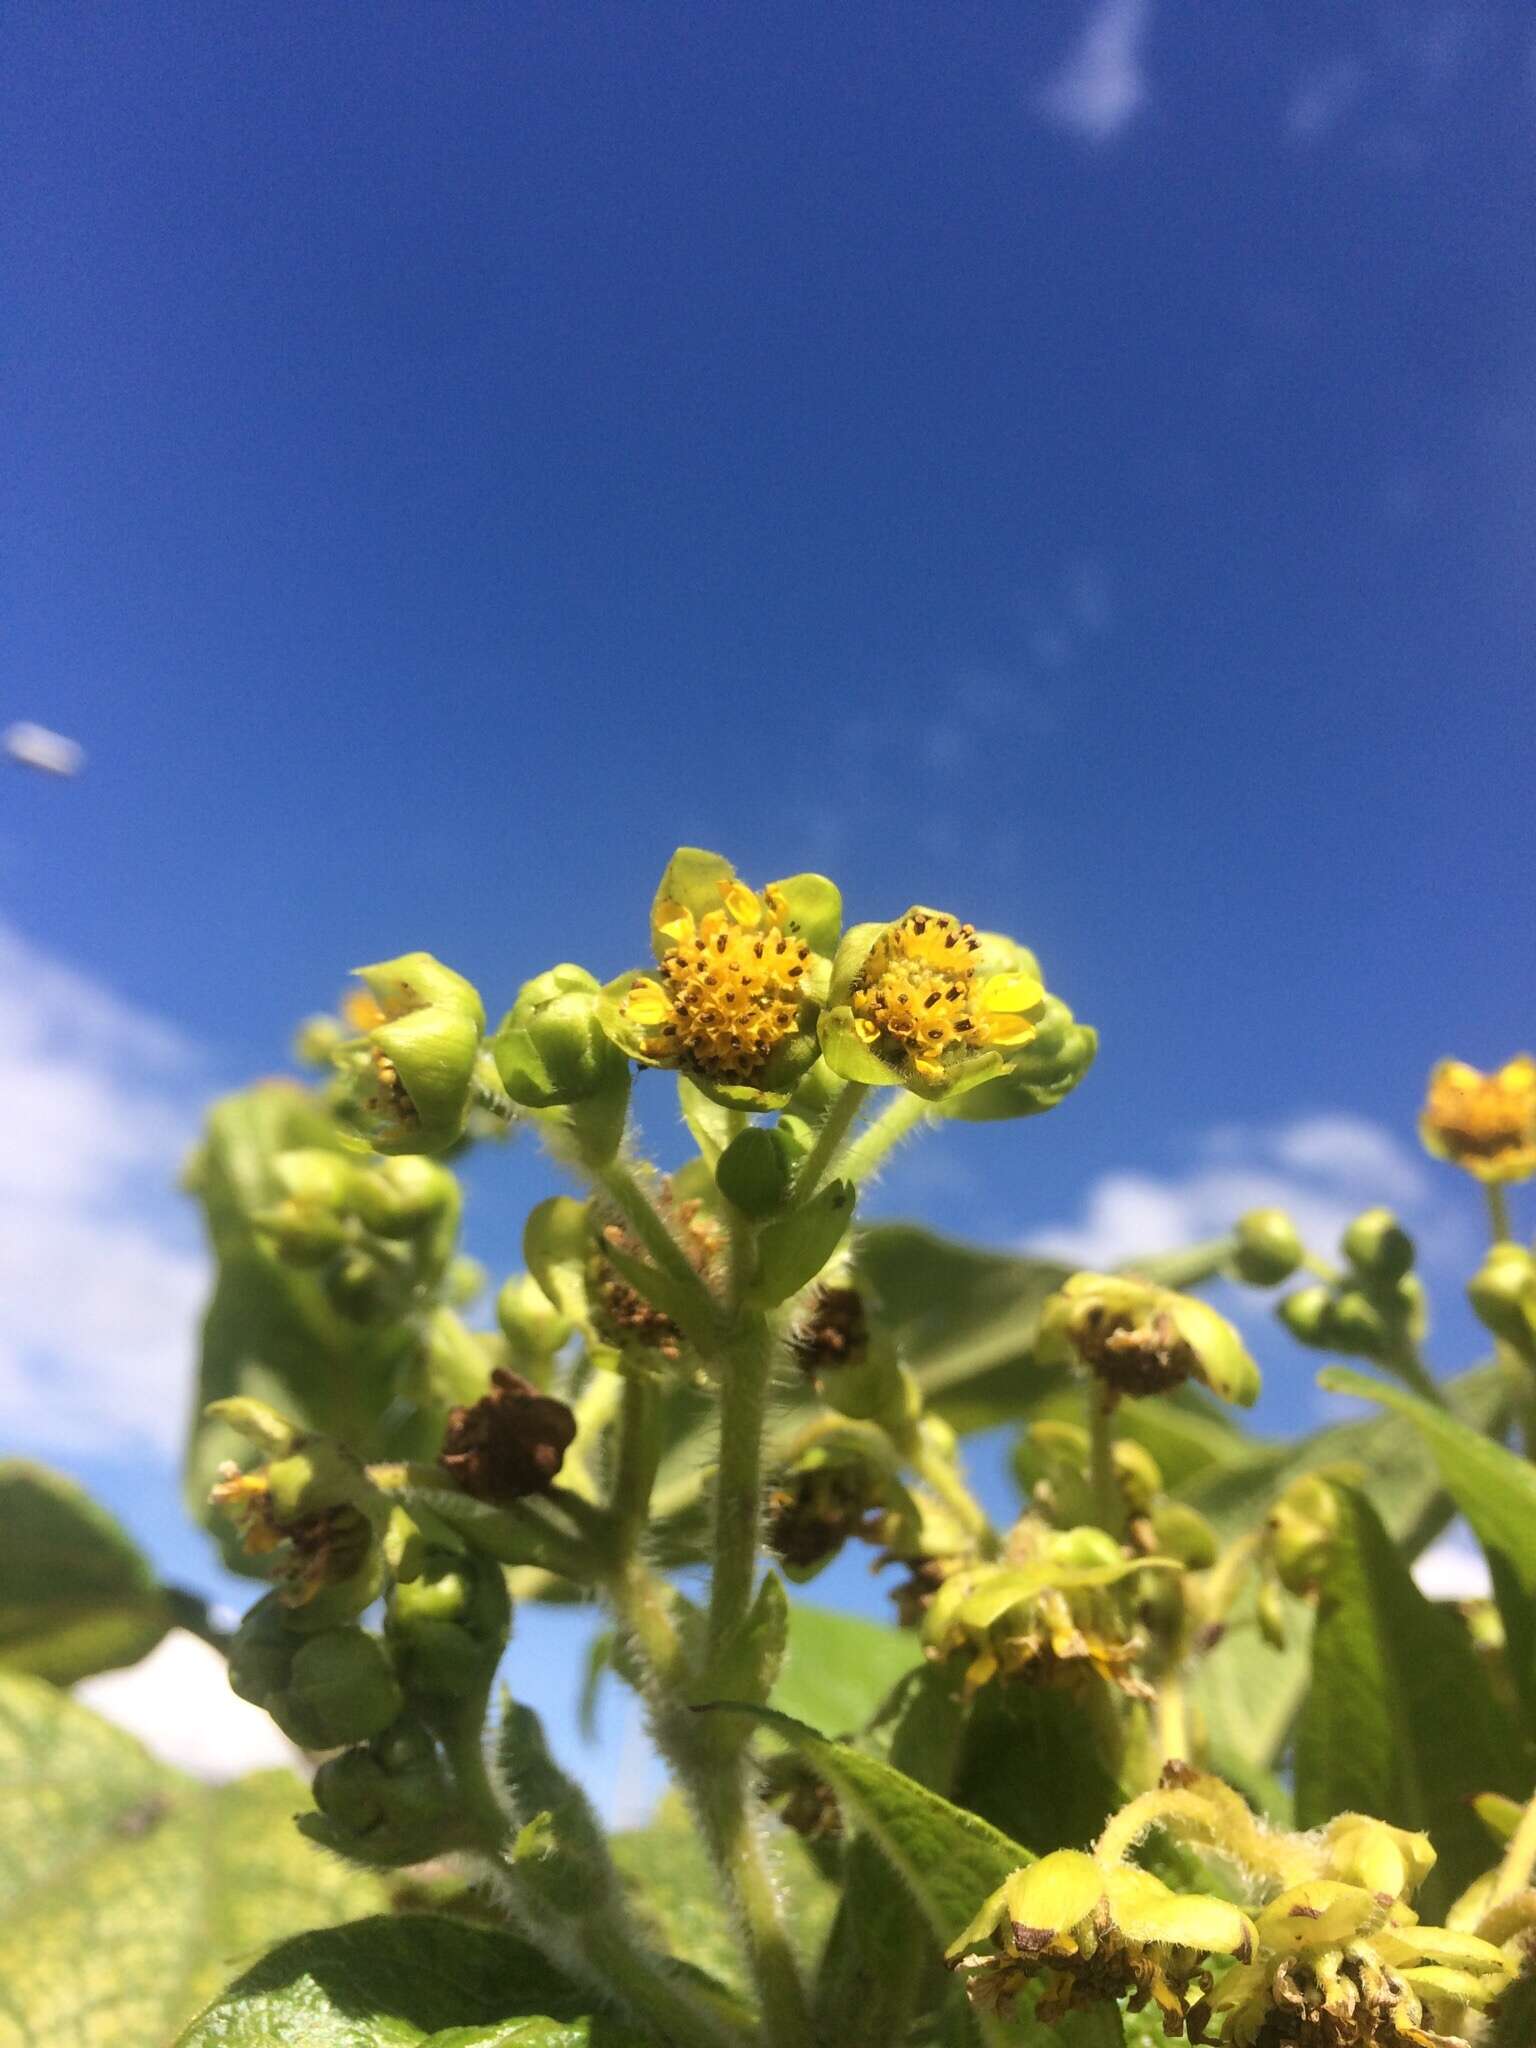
[1296,1487,1526,1919]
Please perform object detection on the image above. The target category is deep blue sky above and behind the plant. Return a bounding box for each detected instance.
[0,0,1536,1794]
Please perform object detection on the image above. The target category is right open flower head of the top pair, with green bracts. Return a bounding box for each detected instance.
[821,905,1047,1102]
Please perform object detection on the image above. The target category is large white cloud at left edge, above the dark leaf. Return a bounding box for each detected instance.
[0,924,205,1456]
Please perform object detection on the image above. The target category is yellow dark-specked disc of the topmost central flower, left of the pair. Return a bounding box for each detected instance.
[625,881,811,1085]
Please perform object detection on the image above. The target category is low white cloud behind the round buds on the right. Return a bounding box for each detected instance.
[1030,1112,1454,1266]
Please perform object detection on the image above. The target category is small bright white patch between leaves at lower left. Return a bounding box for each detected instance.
[76,1628,303,1784]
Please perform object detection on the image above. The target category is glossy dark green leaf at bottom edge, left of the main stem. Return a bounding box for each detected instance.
[169,1913,602,2048]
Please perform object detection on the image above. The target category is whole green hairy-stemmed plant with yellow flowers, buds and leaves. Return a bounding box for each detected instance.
[0,848,1536,2048]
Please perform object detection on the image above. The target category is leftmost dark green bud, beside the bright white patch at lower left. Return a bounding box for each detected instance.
[229,1593,403,1749]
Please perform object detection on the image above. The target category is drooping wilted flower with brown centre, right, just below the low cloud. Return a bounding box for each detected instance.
[1034,1274,1260,1407]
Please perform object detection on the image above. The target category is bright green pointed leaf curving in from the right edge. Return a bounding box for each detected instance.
[1319,1366,1536,1737]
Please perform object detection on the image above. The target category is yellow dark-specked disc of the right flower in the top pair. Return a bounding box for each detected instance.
[850,909,1044,1081]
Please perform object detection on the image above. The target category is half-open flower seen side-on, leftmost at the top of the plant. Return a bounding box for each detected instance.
[344,952,485,1153]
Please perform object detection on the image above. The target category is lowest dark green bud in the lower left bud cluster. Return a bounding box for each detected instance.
[299,1714,463,1868]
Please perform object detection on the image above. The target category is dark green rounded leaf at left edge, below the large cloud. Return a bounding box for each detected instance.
[0,1458,172,1686]
